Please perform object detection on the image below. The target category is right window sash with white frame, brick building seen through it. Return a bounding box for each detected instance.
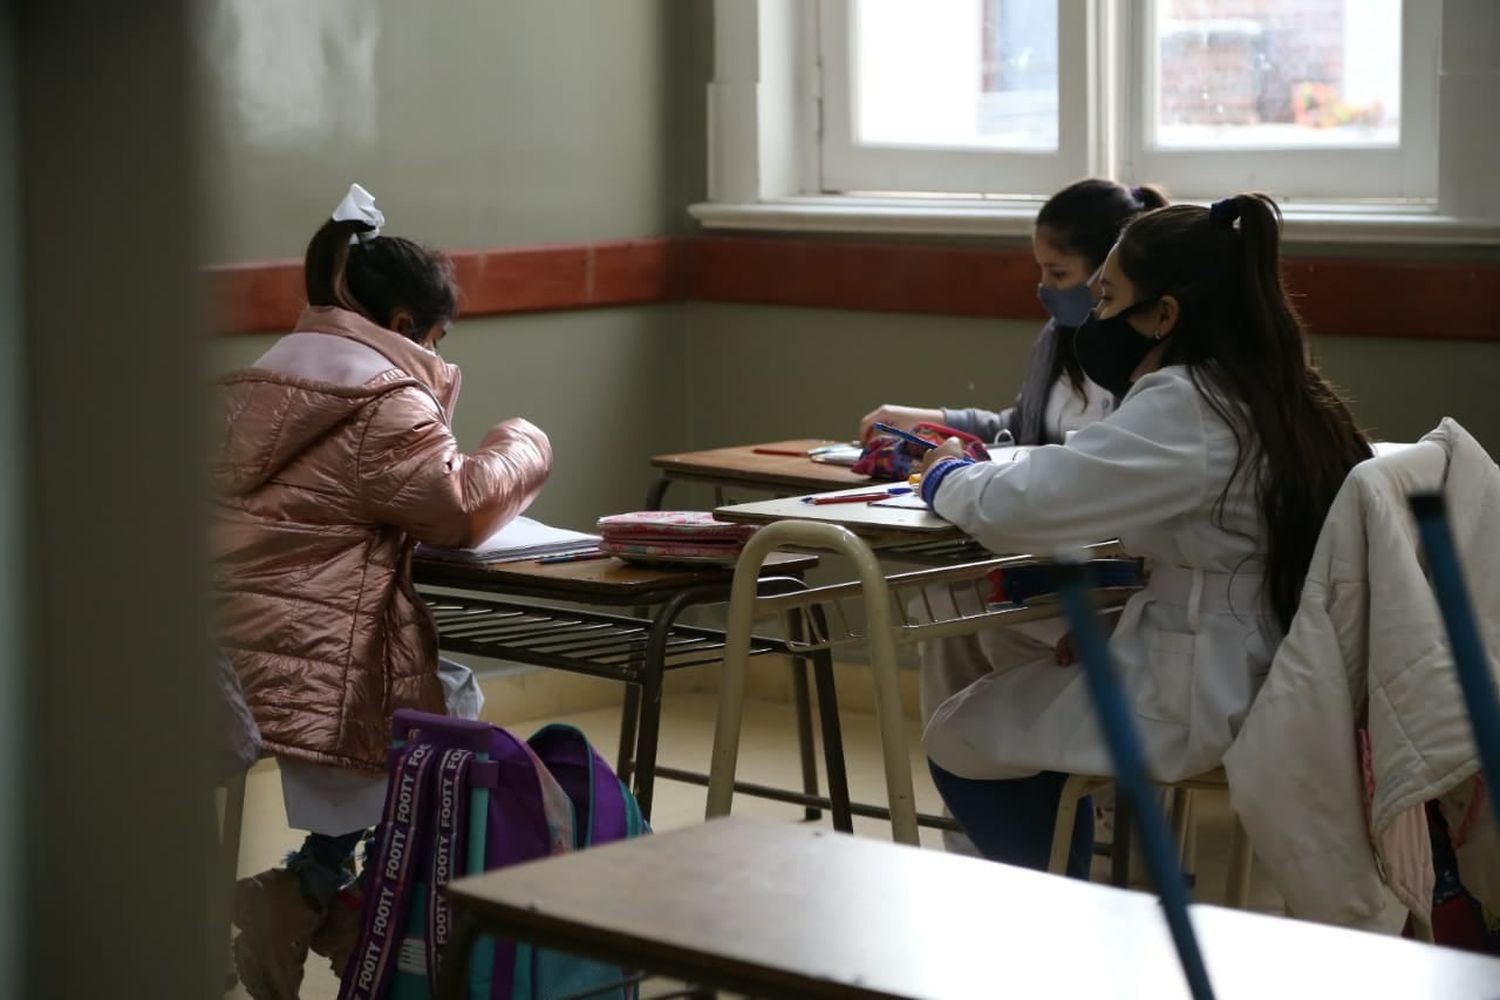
[1122,0,1442,199]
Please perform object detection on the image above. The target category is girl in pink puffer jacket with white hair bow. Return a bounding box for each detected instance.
[213,184,552,1000]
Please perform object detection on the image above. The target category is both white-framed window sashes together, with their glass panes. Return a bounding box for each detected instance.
[819,0,1439,198]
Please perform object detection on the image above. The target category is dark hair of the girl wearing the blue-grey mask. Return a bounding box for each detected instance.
[1037,177,1169,396]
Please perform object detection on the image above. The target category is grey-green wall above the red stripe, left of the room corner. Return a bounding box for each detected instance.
[201,0,692,261]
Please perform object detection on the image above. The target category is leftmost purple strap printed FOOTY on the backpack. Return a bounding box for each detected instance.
[339,742,438,1000]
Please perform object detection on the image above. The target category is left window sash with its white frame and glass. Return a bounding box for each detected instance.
[819,0,1089,193]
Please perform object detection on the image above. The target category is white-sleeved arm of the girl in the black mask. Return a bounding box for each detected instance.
[933,373,1208,552]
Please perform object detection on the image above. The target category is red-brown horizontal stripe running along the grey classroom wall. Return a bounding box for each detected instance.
[207,237,1500,340]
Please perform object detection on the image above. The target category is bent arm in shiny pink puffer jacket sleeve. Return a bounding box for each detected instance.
[357,388,552,547]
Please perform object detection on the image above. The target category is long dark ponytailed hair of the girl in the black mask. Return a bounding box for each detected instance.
[1116,193,1370,628]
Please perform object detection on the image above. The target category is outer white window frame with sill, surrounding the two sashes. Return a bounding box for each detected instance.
[689,0,1500,247]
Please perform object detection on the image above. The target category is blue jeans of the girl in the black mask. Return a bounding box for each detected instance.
[927,760,1094,879]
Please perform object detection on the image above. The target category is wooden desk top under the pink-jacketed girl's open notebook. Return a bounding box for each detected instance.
[411,552,818,604]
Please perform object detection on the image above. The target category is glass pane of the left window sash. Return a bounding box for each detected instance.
[854,0,1058,151]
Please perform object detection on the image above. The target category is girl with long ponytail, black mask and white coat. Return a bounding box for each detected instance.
[923,193,1370,876]
